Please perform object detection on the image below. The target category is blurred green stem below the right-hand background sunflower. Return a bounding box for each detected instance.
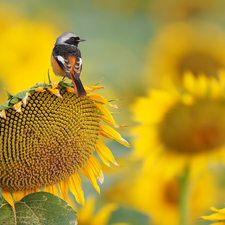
[179,167,190,225]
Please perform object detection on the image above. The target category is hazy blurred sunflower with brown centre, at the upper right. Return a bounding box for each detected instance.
[144,20,225,85]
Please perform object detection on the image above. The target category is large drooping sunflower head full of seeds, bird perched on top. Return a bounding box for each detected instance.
[0,82,129,205]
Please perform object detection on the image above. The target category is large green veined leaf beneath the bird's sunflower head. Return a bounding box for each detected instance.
[0,192,77,225]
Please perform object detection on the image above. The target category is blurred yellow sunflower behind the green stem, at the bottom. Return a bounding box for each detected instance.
[103,172,220,225]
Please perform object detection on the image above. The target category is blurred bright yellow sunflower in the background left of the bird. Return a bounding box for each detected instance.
[0,15,57,95]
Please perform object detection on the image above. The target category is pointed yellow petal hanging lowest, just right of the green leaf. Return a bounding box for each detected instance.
[68,173,84,206]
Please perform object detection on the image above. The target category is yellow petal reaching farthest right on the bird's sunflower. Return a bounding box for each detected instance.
[99,125,131,148]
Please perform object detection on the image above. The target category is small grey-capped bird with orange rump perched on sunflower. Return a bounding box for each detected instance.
[51,32,86,96]
